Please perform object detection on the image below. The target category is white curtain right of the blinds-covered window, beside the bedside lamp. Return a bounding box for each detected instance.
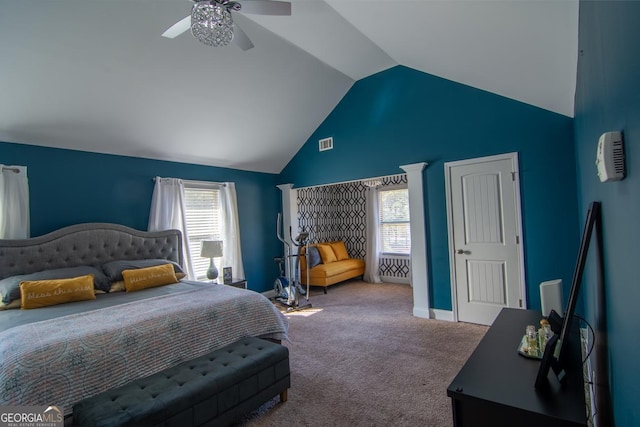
[220,182,245,279]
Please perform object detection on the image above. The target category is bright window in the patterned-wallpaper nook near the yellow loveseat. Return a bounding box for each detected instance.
[378,187,411,255]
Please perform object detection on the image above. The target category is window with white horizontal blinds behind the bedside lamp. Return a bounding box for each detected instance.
[184,181,224,280]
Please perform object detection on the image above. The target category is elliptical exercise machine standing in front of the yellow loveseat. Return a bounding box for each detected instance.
[273,214,311,311]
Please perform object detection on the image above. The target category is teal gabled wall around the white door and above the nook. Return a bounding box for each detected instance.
[280,66,580,310]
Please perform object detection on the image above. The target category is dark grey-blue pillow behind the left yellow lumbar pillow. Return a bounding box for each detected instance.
[0,265,110,304]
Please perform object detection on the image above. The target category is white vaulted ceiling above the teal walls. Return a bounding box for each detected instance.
[0,0,578,173]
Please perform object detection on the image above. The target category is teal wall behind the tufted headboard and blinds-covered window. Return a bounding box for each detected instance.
[0,142,282,292]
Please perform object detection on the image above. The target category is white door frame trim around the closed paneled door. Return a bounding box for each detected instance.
[444,152,527,322]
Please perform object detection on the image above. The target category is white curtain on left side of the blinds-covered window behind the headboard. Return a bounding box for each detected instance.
[148,176,196,279]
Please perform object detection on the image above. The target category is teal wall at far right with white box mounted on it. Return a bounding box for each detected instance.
[574,1,640,426]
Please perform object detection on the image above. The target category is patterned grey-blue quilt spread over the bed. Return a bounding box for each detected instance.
[0,285,288,414]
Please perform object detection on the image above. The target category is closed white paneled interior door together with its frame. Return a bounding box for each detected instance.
[445,153,524,325]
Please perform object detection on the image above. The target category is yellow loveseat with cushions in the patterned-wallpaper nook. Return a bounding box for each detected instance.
[300,241,364,294]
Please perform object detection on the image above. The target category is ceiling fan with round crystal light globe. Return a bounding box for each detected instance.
[162,0,291,50]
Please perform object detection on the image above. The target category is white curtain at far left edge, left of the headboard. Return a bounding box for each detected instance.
[0,165,30,239]
